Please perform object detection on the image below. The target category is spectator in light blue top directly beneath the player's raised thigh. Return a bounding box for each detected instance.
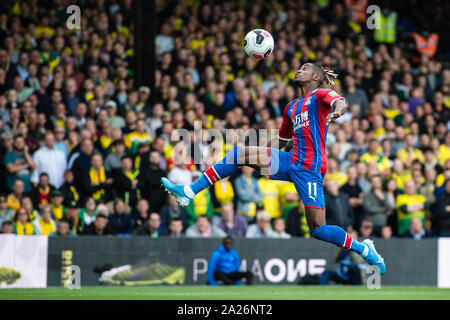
[234,166,262,222]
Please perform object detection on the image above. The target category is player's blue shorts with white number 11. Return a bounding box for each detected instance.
[268,148,325,209]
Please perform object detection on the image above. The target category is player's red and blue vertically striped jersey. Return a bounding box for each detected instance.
[278,88,344,174]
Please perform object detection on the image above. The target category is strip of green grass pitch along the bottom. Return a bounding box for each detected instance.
[0,286,450,300]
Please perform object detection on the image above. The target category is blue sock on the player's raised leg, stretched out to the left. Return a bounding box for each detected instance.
[190,146,242,194]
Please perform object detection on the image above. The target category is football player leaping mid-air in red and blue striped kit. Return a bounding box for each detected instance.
[161,63,386,274]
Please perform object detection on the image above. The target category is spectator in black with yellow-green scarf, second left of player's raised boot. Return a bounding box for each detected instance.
[113,156,140,207]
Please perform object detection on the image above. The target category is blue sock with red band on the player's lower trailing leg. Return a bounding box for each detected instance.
[311,224,365,254]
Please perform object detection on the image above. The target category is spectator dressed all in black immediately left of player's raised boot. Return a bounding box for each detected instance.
[138,151,167,211]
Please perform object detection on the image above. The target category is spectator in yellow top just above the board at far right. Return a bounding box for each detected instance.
[395,180,428,236]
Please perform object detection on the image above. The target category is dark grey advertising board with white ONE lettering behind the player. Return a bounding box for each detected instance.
[47,237,442,286]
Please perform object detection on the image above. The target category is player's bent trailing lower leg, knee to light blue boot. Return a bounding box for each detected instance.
[305,206,386,275]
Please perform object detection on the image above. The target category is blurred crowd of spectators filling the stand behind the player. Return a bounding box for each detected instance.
[0,0,450,239]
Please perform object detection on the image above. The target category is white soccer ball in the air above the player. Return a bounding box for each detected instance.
[244,29,274,59]
